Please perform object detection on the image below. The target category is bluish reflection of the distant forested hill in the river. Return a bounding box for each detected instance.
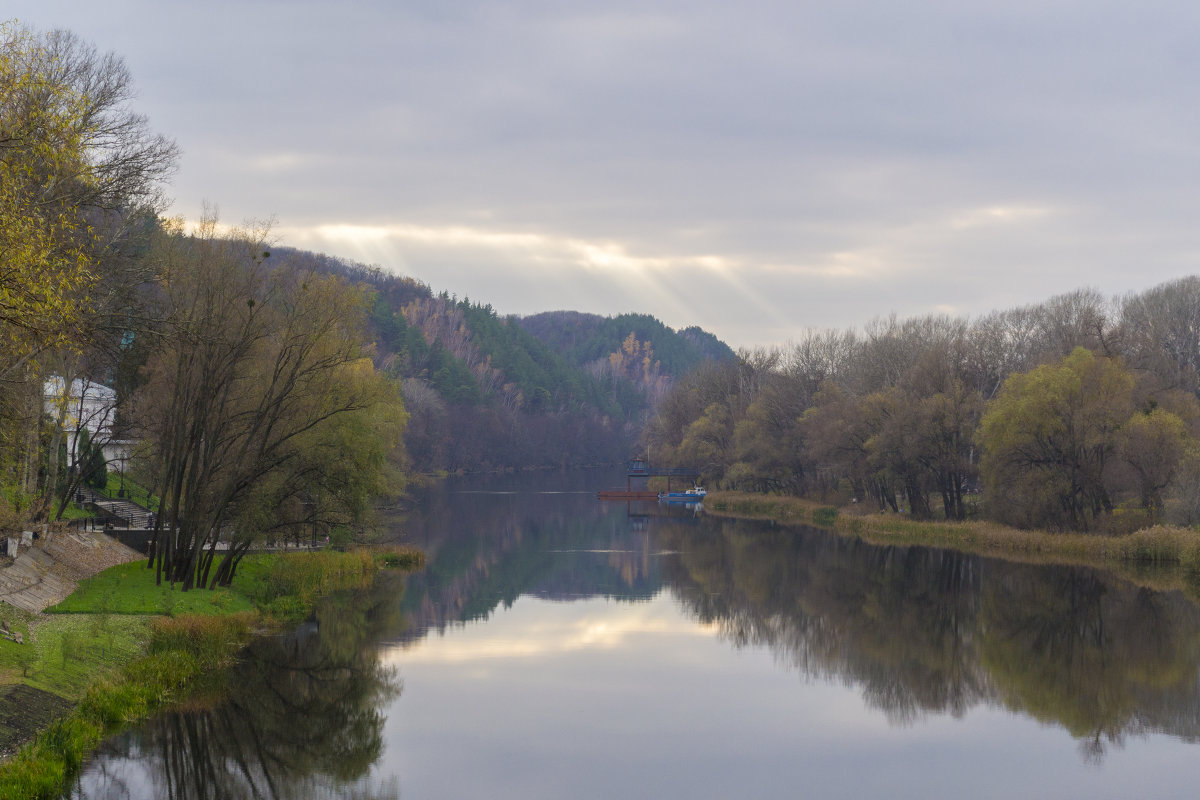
[396,470,676,639]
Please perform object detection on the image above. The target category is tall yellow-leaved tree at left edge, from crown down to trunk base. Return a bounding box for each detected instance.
[0,23,178,522]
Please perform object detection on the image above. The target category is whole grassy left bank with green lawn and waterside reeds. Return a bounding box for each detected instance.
[0,551,419,800]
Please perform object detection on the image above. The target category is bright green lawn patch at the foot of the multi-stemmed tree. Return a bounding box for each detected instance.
[46,561,254,616]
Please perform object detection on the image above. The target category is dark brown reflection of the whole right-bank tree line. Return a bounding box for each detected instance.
[659,522,1200,760]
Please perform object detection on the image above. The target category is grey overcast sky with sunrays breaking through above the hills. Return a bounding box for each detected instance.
[9,0,1200,347]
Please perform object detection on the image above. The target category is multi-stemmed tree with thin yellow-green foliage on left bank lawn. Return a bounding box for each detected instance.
[136,217,406,590]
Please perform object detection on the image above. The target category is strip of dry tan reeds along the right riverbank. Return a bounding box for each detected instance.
[704,492,1200,585]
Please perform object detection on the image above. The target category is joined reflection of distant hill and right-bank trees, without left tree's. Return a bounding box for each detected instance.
[407,477,1200,759]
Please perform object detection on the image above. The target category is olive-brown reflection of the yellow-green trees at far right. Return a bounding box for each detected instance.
[982,565,1200,758]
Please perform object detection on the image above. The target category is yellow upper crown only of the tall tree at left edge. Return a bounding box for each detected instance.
[0,23,178,367]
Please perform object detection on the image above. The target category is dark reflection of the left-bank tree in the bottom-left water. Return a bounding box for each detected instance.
[76,576,401,800]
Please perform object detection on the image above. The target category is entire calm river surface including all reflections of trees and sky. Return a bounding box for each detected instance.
[72,473,1200,800]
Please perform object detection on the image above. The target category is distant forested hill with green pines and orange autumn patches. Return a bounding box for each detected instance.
[272,248,736,471]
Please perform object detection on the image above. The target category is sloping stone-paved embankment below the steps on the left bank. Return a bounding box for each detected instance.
[0,530,143,613]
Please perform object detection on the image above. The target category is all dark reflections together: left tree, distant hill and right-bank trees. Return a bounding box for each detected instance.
[77,479,1200,800]
